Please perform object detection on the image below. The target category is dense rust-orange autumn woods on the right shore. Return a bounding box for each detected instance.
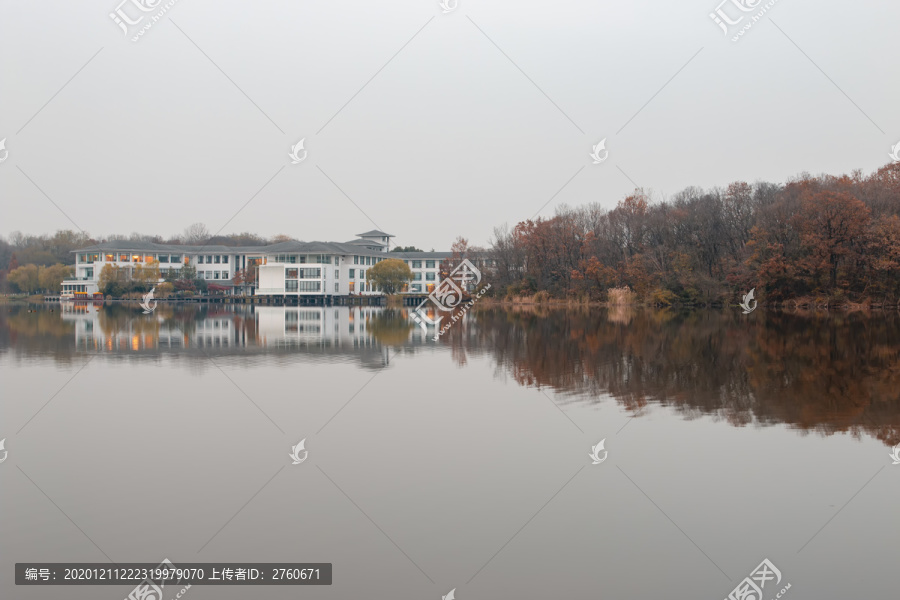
[489,164,900,304]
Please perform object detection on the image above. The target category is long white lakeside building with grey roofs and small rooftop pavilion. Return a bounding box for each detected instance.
[62,230,452,298]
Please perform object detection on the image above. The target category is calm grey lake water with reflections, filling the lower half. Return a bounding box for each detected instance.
[0,305,900,600]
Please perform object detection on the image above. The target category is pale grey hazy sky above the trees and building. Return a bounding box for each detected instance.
[0,0,900,250]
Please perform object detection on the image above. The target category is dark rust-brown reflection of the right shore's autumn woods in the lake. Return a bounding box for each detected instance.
[466,309,900,445]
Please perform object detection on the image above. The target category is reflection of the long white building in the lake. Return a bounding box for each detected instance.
[61,303,433,352]
